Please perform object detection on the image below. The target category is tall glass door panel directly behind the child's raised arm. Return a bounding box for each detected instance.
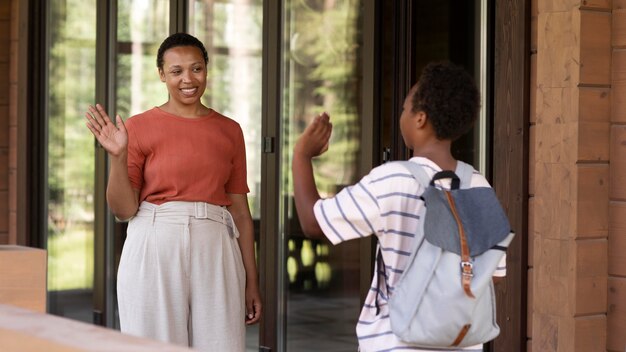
[279,0,361,351]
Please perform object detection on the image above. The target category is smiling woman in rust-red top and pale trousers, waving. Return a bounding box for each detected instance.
[85,33,261,351]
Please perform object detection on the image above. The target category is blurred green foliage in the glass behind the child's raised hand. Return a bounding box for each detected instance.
[283,0,360,194]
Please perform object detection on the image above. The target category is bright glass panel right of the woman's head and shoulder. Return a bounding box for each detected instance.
[188,0,263,351]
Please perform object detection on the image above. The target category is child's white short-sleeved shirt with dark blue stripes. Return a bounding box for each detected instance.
[314,157,506,352]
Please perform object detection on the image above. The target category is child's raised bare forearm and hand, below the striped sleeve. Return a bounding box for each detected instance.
[291,113,333,237]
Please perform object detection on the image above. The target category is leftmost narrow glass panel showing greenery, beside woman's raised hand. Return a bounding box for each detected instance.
[46,0,96,322]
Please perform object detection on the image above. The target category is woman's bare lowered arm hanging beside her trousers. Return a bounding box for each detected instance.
[228,193,263,324]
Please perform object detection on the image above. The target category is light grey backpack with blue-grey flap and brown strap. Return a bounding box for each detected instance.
[377,161,514,349]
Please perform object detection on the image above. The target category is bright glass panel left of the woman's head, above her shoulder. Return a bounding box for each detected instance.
[115,0,170,119]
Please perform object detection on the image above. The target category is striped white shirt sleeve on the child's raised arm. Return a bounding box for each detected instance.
[313,176,380,244]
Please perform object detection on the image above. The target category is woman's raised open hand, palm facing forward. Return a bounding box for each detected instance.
[85,104,128,156]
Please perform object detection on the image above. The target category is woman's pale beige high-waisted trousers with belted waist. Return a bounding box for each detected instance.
[117,202,245,352]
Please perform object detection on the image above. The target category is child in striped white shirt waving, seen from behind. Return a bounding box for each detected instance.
[292,62,512,352]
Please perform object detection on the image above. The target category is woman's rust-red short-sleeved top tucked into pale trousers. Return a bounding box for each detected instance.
[126,108,249,205]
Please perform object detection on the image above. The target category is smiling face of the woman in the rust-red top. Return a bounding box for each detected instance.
[159,46,207,105]
